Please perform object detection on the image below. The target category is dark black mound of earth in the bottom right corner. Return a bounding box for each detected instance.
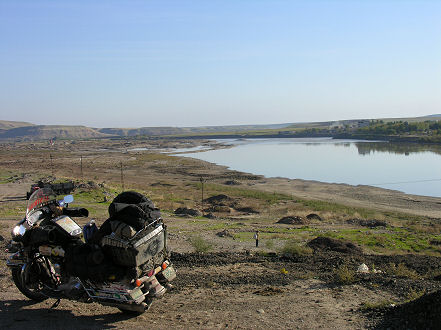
[375,290,441,329]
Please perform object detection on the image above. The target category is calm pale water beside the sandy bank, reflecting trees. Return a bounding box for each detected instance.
[180,138,441,197]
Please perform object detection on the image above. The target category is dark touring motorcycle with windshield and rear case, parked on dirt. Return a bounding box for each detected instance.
[7,188,176,314]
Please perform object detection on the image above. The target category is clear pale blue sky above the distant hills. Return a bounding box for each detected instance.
[0,0,441,127]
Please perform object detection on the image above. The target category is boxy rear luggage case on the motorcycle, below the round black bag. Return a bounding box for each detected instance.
[101,221,167,267]
